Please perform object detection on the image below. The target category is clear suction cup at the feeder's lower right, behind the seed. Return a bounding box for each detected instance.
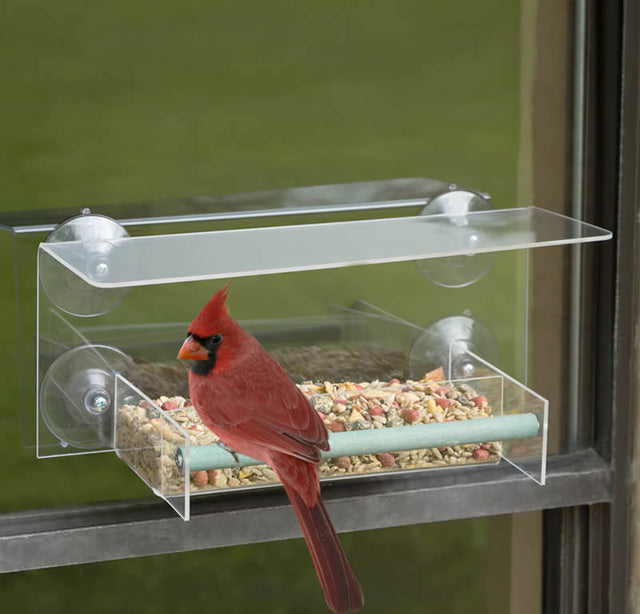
[409,315,500,379]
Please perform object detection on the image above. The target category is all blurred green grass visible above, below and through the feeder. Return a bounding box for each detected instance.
[0,0,526,613]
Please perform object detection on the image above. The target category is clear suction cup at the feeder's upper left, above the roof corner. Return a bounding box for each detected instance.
[40,209,129,317]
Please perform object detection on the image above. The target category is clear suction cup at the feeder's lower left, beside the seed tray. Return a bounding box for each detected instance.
[40,345,133,450]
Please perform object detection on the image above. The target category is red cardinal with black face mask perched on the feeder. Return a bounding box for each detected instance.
[178,285,364,614]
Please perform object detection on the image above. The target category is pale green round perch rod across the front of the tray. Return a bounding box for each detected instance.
[176,413,540,471]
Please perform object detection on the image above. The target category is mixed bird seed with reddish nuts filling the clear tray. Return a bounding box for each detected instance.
[116,369,502,495]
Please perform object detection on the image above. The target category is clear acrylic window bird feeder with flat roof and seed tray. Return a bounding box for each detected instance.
[0,179,611,519]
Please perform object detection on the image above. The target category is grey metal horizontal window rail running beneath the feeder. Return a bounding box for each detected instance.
[0,450,612,573]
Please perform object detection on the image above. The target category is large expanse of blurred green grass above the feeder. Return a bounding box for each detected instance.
[0,0,519,209]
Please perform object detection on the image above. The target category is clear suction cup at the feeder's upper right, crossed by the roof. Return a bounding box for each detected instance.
[416,189,496,288]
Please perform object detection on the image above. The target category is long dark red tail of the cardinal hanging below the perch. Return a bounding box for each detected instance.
[284,483,364,614]
